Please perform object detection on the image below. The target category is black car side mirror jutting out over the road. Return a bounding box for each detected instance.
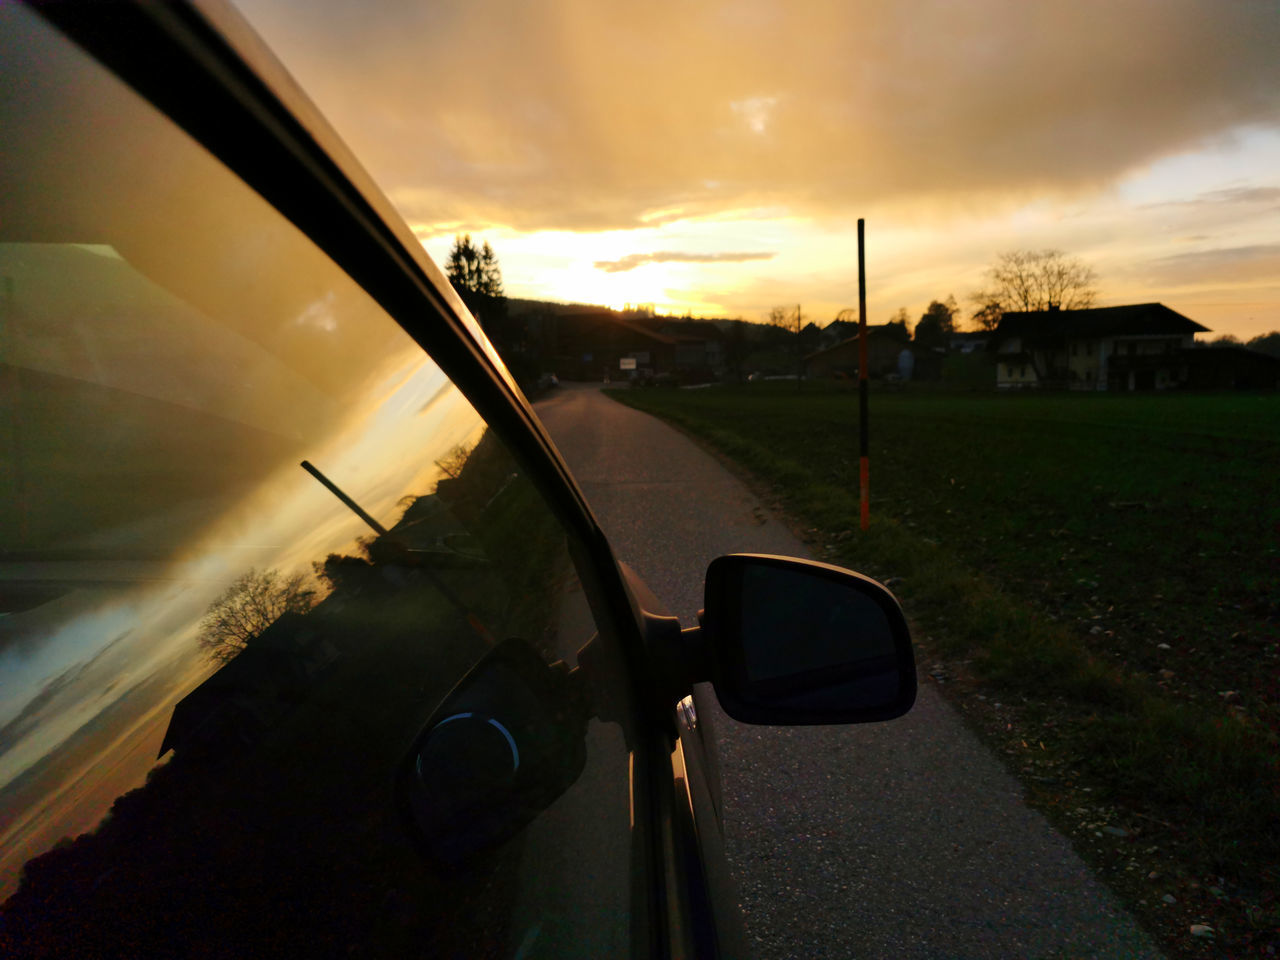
[700,554,915,723]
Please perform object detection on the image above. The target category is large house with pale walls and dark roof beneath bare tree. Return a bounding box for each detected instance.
[988,303,1208,390]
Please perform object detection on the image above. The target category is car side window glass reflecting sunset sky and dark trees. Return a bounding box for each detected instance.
[0,4,634,956]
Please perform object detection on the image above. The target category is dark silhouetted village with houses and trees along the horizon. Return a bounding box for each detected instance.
[496,300,1280,392]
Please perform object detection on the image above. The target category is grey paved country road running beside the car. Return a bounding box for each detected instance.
[538,385,1160,960]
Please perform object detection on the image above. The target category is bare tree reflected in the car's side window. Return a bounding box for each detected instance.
[197,568,322,663]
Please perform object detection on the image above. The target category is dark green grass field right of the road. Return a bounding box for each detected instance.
[616,383,1280,946]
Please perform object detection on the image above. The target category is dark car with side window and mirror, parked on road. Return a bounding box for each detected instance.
[0,0,915,957]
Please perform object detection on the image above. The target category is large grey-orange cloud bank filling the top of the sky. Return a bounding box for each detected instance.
[239,0,1280,230]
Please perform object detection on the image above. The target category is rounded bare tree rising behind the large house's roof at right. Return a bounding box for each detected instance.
[969,250,1097,321]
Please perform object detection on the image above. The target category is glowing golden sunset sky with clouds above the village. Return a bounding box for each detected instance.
[237,0,1280,339]
